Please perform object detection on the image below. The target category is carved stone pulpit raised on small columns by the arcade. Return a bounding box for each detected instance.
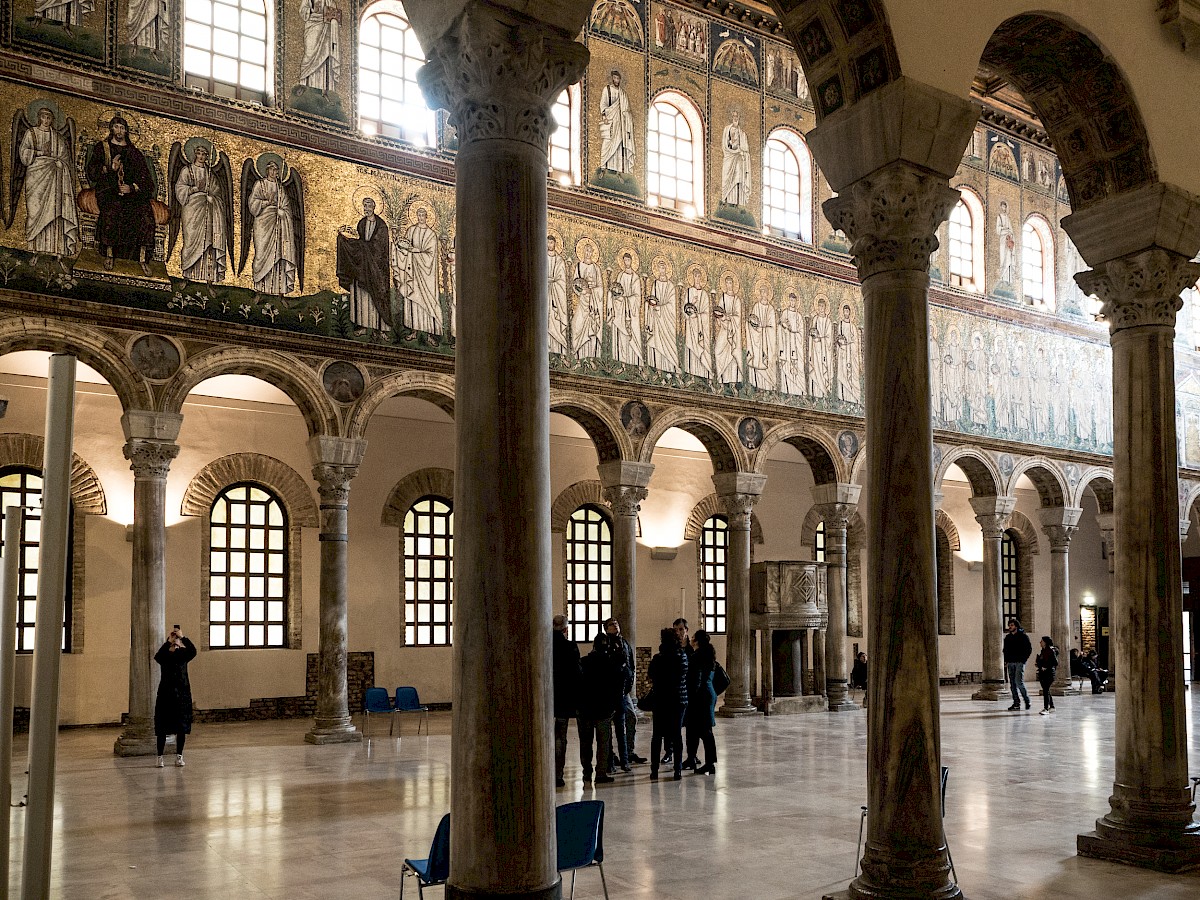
[750,560,829,715]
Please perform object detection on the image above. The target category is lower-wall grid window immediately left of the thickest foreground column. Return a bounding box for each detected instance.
[404,497,454,647]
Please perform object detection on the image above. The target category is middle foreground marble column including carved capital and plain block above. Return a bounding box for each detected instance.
[809,78,979,900]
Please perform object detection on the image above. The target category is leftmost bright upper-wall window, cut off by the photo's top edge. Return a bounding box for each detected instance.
[184,0,269,103]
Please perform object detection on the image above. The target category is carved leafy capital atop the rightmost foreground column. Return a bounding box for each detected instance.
[1075,247,1200,331]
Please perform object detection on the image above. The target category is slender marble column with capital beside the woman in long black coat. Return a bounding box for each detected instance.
[113,409,184,756]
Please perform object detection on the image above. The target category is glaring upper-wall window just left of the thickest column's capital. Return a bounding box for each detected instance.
[359,0,437,146]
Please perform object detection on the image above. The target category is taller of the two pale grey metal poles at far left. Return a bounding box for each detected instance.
[20,353,76,900]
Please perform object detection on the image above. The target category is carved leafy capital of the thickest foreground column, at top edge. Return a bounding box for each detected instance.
[416,4,589,152]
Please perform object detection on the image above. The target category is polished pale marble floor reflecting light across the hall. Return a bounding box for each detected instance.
[11,688,1200,900]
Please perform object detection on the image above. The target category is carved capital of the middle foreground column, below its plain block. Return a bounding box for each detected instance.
[823,162,961,281]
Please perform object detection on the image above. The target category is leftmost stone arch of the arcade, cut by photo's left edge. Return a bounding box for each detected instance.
[0,316,154,410]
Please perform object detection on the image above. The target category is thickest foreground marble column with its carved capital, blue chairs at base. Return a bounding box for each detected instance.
[418,2,588,900]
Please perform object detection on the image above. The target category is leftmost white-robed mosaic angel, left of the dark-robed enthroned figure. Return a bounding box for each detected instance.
[18,115,79,257]
